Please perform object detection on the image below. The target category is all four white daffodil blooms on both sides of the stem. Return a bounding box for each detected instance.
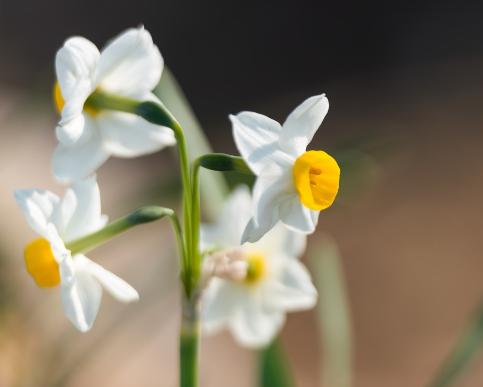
[15,28,340,347]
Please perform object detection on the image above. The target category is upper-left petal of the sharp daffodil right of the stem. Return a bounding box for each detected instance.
[230,112,293,175]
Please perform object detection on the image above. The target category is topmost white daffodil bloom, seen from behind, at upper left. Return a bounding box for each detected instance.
[52,27,175,182]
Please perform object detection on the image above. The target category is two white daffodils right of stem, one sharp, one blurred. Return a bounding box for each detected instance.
[201,95,340,347]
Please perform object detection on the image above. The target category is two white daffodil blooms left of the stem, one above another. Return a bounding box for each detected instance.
[15,28,175,332]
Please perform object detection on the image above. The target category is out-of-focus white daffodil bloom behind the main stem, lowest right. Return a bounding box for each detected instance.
[201,187,317,348]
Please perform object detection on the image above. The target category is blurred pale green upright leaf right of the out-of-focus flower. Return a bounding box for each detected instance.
[309,237,352,387]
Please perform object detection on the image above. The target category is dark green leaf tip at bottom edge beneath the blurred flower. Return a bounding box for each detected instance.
[258,339,295,387]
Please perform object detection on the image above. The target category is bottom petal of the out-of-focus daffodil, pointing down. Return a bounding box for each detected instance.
[230,299,285,348]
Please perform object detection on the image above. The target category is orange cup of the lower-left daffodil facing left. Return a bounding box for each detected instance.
[24,238,60,288]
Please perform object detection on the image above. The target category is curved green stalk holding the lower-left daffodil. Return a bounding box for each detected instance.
[66,206,178,255]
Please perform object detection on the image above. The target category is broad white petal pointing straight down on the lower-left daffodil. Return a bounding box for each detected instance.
[61,265,102,332]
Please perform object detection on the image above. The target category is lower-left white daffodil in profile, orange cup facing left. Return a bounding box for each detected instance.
[15,176,139,332]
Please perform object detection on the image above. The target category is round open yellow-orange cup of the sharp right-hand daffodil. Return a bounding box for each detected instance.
[293,151,340,211]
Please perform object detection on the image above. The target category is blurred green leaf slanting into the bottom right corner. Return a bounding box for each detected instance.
[429,304,483,387]
